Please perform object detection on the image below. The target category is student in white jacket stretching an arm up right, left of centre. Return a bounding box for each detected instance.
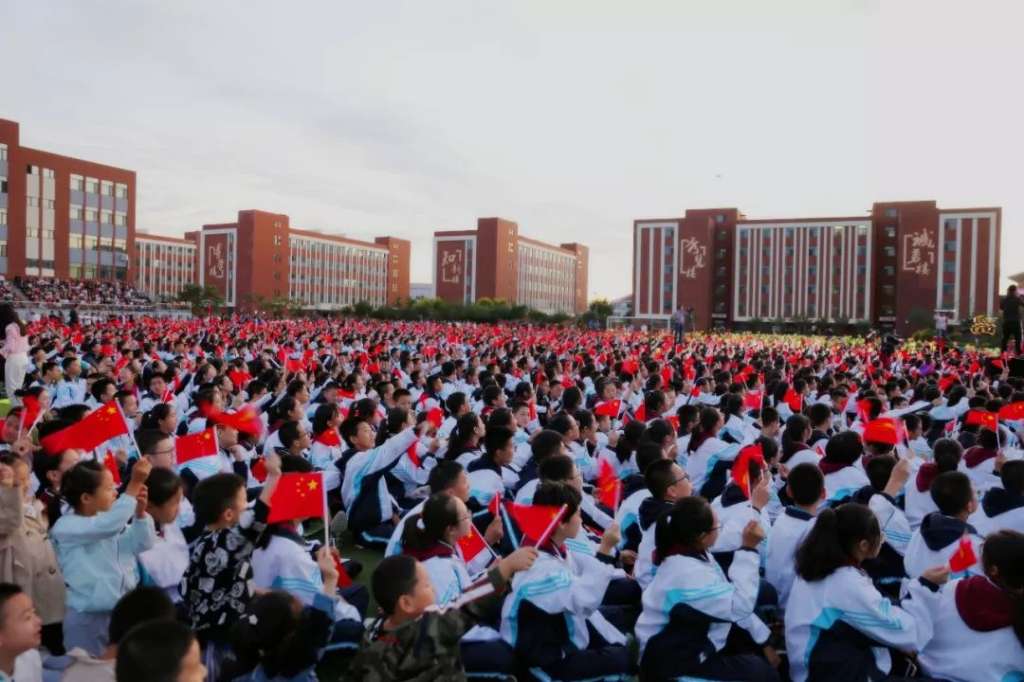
[341,408,430,547]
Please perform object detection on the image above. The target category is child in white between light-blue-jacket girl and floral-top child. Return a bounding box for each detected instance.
[138,467,188,603]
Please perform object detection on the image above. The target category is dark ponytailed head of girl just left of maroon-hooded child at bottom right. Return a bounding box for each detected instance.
[797,502,882,582]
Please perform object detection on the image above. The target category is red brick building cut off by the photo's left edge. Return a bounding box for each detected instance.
[0,119,135,282]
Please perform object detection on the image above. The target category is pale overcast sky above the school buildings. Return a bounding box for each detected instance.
[0,0,1024,298]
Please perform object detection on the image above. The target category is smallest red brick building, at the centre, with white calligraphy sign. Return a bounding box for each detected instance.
[434,218,590,314]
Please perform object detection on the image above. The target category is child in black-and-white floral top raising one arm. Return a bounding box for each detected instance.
[181,453,281,677]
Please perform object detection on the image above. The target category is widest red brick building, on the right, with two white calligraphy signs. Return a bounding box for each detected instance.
[633,202,1001,332]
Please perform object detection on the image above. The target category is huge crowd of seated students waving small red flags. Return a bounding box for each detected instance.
[0,318,1024,682]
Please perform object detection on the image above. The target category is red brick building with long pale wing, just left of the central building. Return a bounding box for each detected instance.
[195,210,410,310]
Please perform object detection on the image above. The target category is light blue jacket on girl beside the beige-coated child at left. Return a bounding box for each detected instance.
[50,495,157,612]
